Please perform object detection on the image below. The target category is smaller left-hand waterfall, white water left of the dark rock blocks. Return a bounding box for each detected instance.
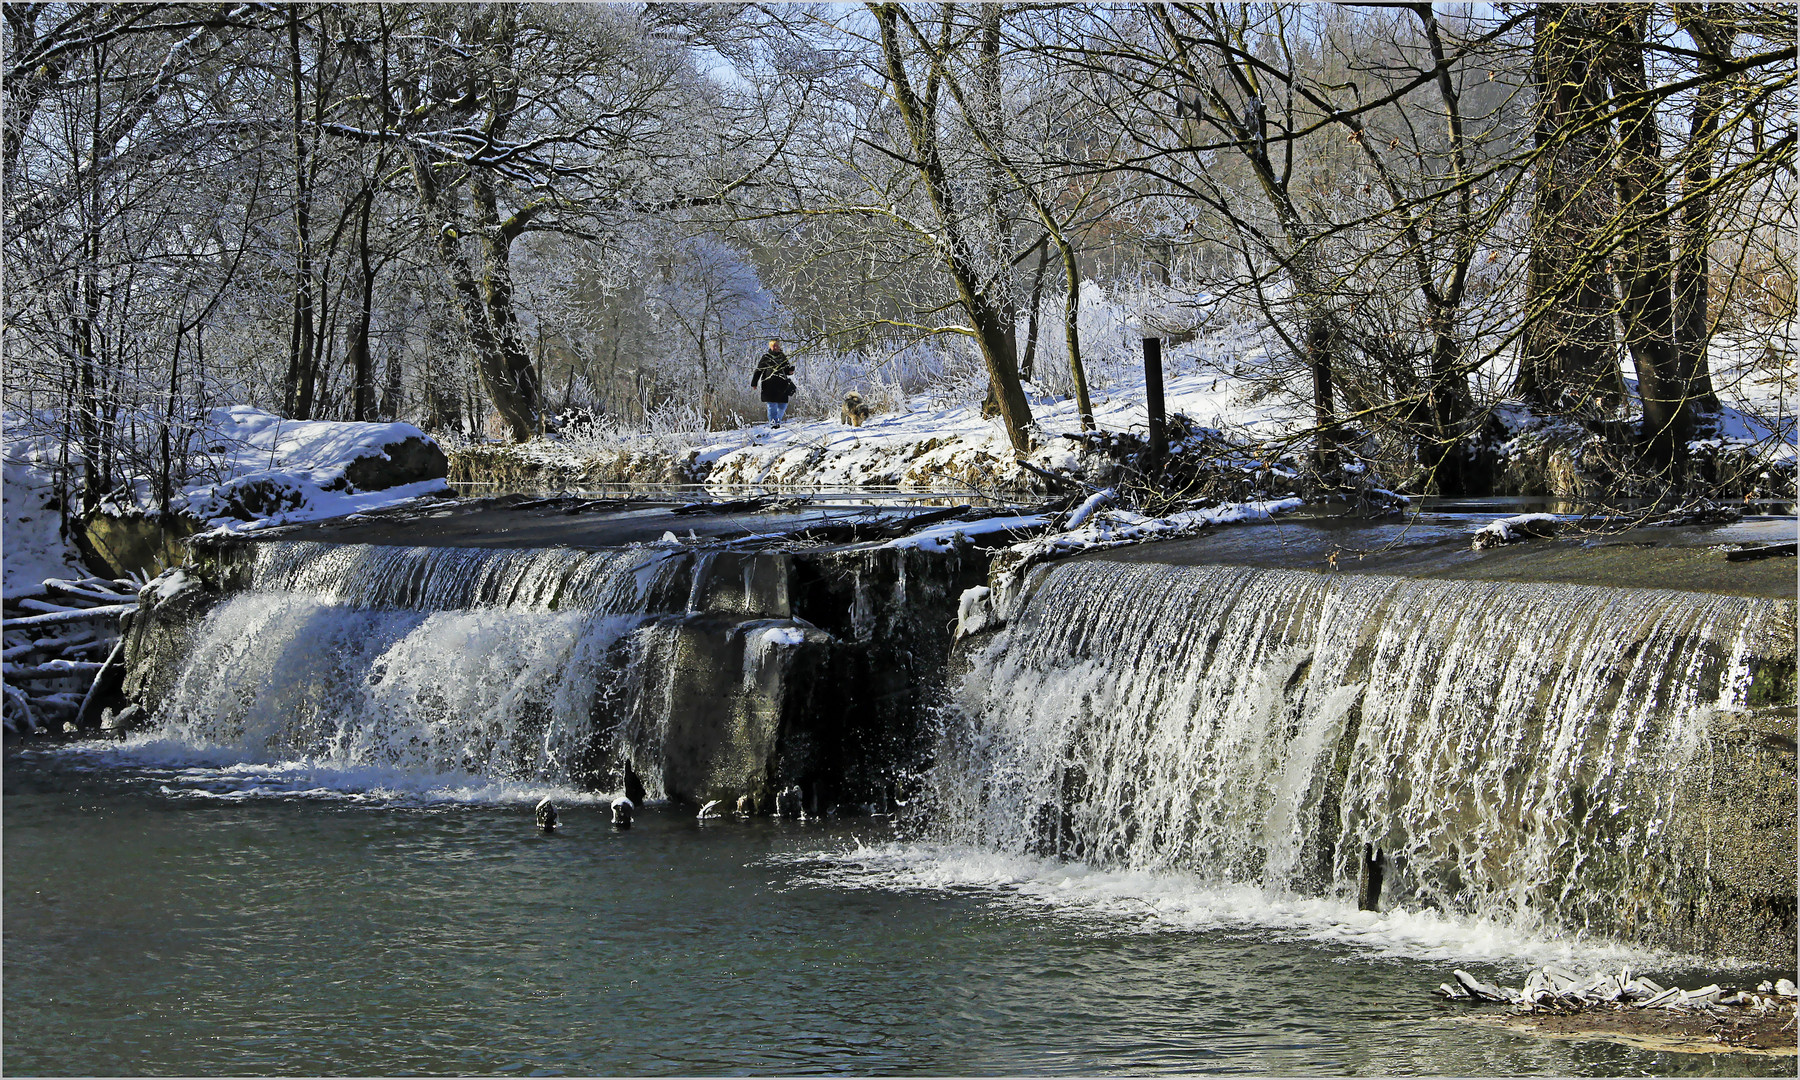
[158,542,723,797]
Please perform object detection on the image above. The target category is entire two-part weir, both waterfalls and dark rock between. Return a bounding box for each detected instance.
[126,507,1795,963]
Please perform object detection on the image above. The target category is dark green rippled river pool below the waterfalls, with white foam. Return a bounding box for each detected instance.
[4,747,1793,1075]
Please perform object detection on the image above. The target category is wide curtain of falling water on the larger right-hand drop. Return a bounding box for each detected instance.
[927,562,1777,936]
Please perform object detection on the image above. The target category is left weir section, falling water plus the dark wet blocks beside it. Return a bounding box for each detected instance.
[126,542,981,812]
